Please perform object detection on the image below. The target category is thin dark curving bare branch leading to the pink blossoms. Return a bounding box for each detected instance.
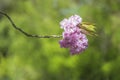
[0,11,62,38]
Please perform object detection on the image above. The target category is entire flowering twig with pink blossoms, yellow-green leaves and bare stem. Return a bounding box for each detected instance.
[0,11,97,55]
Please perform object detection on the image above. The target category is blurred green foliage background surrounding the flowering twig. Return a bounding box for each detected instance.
[0,0,120,80]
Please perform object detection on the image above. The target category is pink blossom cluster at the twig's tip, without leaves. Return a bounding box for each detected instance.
[59,15,88,55]
